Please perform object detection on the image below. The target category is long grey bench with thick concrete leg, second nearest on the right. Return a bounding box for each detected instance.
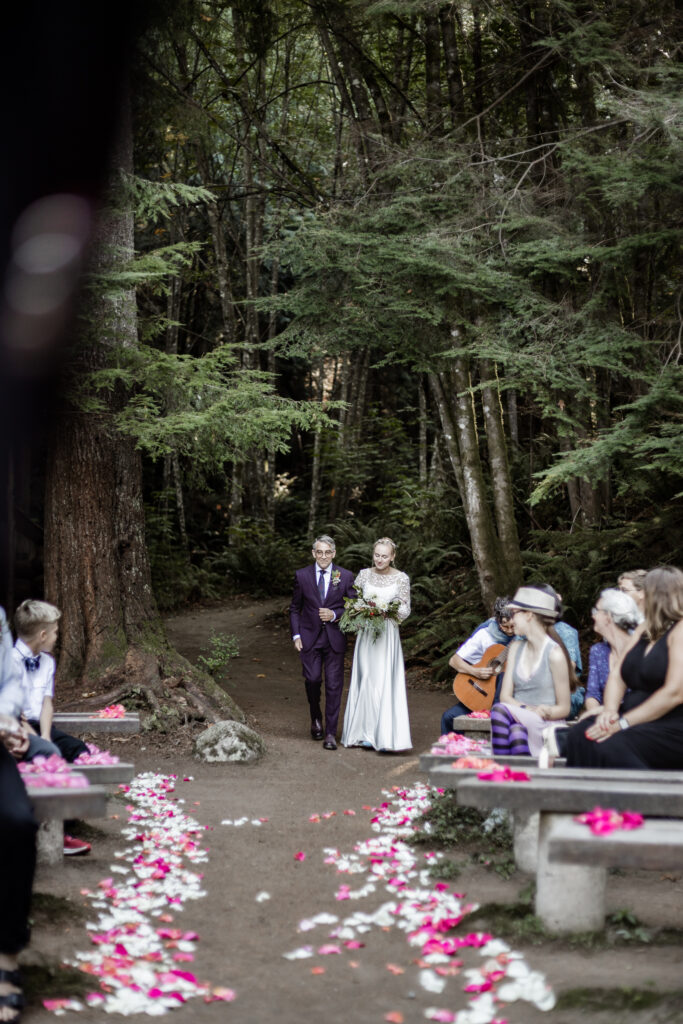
[454,768,683,933]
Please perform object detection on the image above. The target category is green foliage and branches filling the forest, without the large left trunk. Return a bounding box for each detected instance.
[129,0,683,622]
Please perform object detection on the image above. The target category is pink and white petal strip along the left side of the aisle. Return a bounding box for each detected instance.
[44,773,234,1017]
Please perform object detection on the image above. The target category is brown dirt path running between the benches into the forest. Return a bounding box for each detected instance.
[24,600,683,1024]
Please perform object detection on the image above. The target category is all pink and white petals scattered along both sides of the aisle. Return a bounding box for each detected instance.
[44,773,555,1024]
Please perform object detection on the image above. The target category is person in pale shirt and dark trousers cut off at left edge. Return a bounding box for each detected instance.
[0,608,38,1021]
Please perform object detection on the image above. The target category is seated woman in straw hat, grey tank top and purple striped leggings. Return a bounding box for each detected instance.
[490,586,577,756]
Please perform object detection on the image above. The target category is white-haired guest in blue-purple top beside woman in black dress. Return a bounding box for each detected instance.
[583,589,643,718]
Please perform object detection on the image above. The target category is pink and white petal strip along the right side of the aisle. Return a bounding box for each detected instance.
[283,783,555,1024]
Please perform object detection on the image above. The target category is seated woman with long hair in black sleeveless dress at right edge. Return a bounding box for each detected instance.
[566,566,683,770]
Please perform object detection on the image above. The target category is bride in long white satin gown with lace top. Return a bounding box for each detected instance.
[341,537,413,751]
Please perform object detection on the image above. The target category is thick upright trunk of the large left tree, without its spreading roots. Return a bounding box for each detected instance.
[45,103,163,682]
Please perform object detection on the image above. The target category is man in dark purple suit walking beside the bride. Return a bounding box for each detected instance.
[290,536,355,751]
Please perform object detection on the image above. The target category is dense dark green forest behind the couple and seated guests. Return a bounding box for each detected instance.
[6,0,683,688]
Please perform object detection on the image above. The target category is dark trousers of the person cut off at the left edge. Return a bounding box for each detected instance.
[0,743,38,956]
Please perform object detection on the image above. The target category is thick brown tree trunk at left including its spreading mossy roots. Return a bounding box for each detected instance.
[45,92,244,722]
